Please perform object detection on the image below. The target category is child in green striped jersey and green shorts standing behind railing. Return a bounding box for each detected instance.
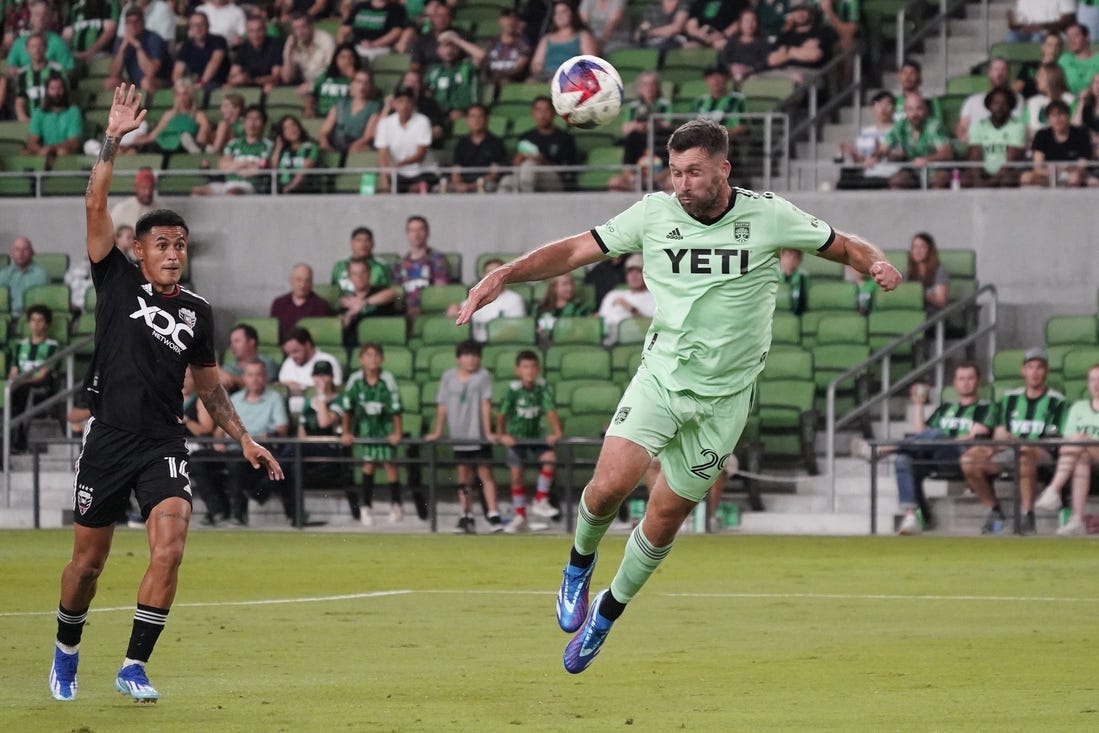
[340,342,404,526]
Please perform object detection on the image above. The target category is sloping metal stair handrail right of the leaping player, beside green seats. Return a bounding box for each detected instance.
[824,285,999,511]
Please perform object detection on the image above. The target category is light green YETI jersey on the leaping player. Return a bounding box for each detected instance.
[591,188,835,397]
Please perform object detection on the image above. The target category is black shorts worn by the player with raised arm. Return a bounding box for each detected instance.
[73,418,191,527]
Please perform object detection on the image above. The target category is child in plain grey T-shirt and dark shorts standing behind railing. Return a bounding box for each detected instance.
[423,341,503,534]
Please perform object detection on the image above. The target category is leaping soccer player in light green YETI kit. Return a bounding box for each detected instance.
[458,120,901,674]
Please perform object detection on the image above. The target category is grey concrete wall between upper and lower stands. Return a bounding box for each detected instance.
[0,190,1099,347]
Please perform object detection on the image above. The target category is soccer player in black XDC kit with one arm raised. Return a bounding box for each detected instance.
[49,86,282,702]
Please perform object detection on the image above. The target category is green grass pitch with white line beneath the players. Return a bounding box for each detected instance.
[0,531,1099,733]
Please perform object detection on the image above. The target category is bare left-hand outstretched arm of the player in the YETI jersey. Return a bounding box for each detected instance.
[457,232,607,325]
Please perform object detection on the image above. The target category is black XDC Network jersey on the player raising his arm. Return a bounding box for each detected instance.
[84,247,217,437]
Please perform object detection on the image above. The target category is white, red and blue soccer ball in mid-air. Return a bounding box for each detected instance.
[550,56,622,130]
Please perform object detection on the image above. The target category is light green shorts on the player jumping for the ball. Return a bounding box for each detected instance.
[607,364,753,501]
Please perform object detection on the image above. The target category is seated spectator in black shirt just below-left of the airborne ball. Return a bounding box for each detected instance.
[500,97,579,191]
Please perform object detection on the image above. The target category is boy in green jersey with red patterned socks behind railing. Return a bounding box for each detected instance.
[496,351,562,534]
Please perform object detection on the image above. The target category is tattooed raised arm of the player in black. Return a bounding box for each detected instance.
[84,85,145,263]
